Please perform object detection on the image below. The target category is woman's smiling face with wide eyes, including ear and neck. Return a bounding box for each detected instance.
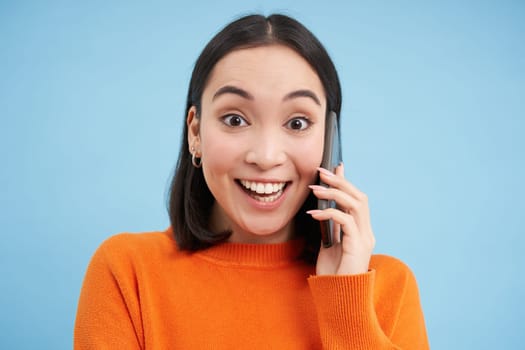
[188,45,326,243]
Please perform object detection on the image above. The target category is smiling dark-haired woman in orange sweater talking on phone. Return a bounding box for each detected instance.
[75,15,428,349]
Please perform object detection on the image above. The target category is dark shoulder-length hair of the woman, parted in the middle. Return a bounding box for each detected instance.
[168,14,341,262]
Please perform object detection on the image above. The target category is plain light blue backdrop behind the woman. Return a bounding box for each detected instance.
[0,0,525,349]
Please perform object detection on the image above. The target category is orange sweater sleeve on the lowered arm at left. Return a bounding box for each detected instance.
[74,237,143,350]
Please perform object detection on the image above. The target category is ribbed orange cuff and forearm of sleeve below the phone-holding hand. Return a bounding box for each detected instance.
[308,270,391,349]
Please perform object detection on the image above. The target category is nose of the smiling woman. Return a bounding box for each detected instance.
[246,130,286,170]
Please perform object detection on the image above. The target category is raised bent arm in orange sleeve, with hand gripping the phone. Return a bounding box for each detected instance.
[309,165,428,349]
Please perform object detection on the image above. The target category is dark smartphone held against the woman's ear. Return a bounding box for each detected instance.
[317,111,343,248]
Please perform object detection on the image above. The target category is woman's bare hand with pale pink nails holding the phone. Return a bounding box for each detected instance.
[307,164,375,275]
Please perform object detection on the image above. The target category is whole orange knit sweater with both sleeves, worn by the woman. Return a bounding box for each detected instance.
[74,230,428,350]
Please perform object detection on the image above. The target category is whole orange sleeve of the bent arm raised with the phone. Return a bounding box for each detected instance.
[308,257,429,350]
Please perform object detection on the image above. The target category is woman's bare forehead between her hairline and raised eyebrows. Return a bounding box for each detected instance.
[205,44,324,97]
